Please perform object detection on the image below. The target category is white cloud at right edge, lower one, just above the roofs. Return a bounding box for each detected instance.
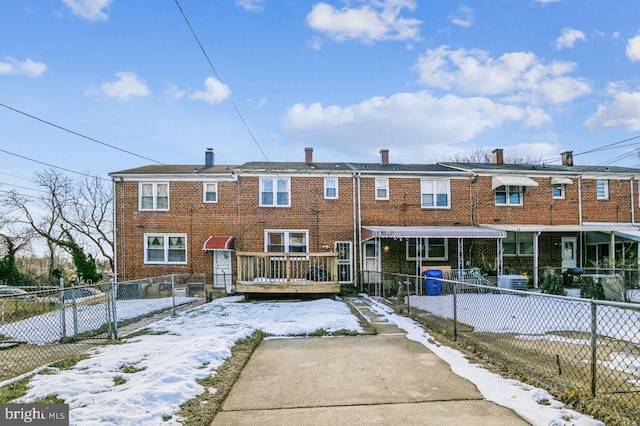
[585,86,640,132]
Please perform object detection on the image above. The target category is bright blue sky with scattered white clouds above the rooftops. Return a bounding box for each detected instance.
[0,0,640,190]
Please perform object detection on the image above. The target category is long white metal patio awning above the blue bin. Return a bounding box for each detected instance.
[362,226,507,241]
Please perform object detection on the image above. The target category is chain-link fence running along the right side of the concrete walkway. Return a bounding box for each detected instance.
[363,271,640,424]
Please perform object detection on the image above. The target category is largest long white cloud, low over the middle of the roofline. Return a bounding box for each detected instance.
[282,91,528,161]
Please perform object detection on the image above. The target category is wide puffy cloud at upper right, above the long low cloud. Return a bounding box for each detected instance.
[416,46,591,104]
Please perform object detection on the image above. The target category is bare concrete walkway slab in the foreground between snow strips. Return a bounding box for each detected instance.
[212,298,529,426]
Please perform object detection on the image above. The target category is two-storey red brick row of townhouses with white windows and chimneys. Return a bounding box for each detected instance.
[110,148,640,287]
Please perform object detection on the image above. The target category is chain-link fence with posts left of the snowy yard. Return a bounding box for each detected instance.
[0,274,213,386]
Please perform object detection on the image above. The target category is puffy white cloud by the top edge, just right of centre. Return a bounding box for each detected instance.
[307,0,422,44]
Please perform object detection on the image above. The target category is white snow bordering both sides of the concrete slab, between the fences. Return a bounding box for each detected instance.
[12,297,602,426]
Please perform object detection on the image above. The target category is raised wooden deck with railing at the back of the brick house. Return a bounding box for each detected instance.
[236,252,340,294]
